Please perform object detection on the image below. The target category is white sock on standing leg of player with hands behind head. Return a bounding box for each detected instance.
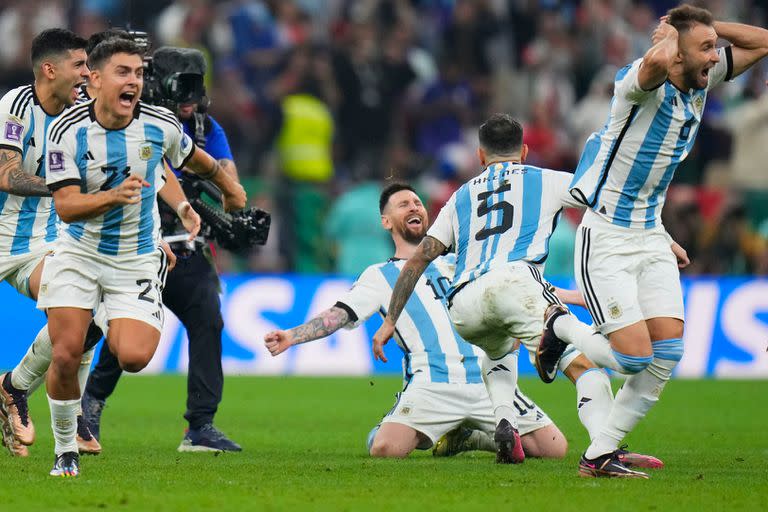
[586,357,677,459]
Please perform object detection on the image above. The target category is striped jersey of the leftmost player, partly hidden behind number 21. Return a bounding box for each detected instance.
[0,85,58,257]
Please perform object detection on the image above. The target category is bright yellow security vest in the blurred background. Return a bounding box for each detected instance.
[277,94,333,183]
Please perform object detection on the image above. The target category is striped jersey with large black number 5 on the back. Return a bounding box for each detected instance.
[427,162,580,289]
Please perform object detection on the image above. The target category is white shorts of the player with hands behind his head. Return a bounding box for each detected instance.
[574,211,684,336]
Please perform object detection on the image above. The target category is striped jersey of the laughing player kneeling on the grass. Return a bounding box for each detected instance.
[336,255,483,384]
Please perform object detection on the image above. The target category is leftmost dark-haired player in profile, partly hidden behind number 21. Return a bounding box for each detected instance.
[0,29,88,456]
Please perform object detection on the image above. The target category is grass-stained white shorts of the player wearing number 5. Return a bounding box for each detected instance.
[449,262,579,368]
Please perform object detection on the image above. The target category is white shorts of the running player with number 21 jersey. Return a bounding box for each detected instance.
[37,241,168,331]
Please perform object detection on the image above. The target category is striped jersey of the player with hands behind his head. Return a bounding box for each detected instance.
[571,46,733,229]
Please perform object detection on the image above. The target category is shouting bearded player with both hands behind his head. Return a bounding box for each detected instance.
[539,5,768,477]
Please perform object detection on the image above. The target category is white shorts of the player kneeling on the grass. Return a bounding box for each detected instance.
[381,383,552,450]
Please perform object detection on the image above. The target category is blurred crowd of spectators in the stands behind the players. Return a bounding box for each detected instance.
[0,0,768,276]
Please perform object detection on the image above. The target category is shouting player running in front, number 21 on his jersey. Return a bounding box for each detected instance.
[38,39,245,476]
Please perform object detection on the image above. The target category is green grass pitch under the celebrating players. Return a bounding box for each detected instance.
[0,376,768,512]
